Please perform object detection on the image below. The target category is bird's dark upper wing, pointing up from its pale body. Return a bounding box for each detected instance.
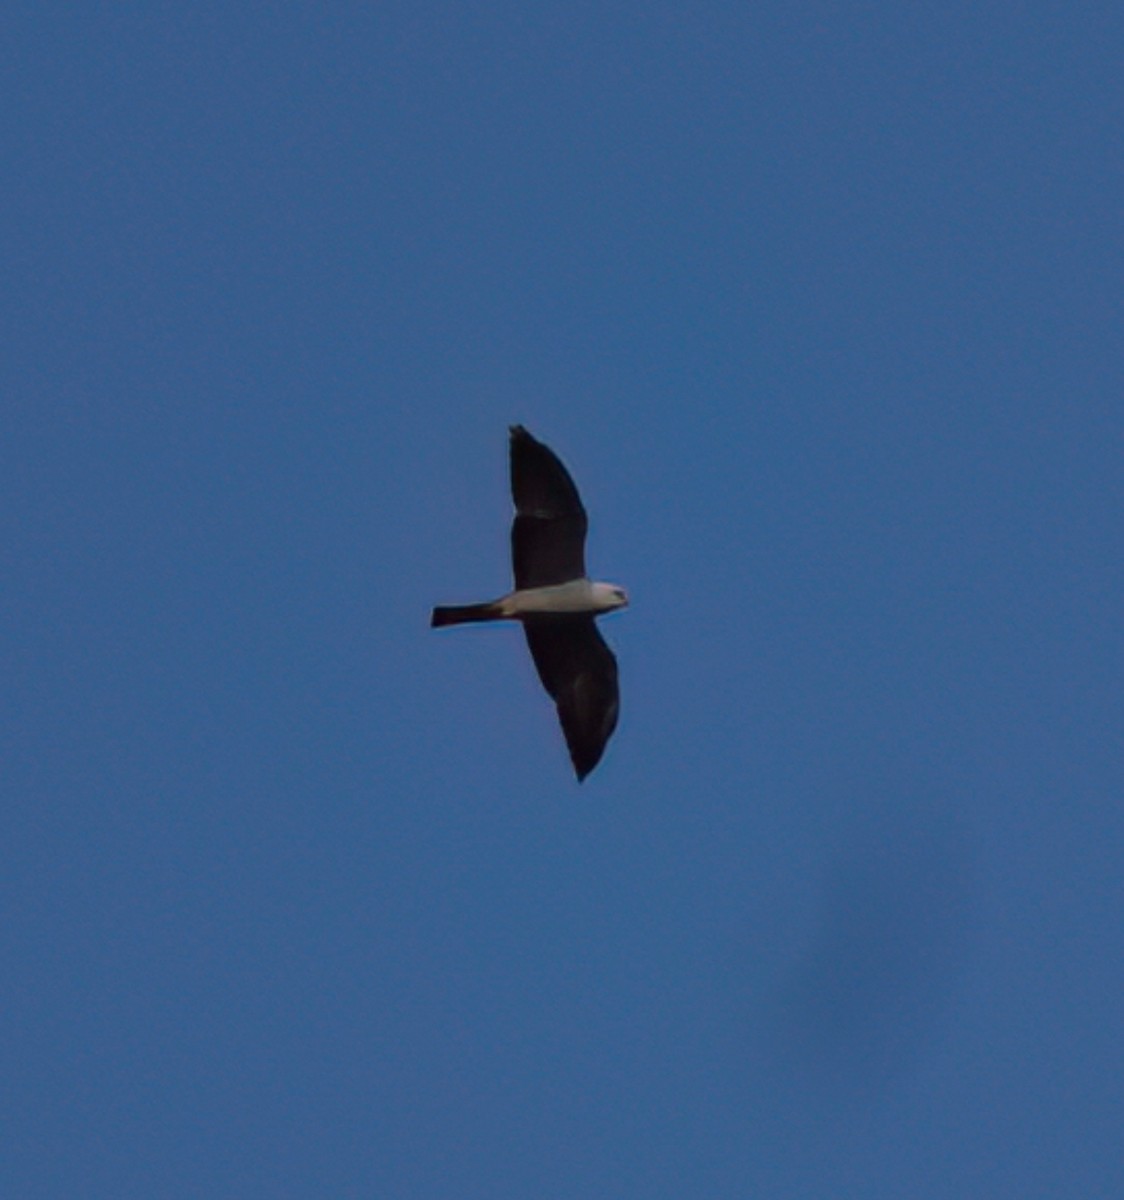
[511,425,588,588]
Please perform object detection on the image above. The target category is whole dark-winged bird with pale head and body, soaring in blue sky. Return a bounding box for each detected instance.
[431,425,629,780]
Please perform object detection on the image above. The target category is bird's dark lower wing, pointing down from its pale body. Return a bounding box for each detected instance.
[523,616,620,780]
